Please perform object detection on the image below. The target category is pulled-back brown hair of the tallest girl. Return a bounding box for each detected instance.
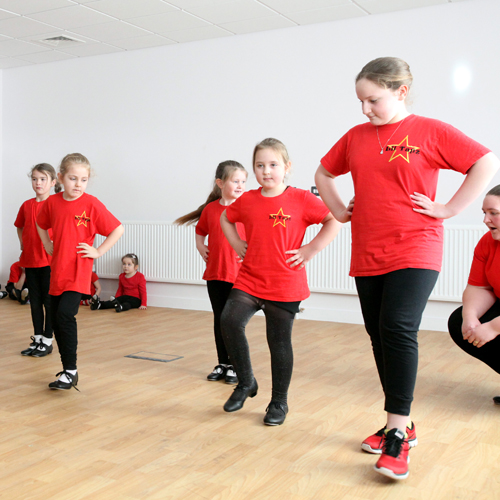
[356,57,413,90]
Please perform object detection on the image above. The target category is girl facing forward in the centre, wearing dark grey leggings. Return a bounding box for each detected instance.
[221,139,340,425]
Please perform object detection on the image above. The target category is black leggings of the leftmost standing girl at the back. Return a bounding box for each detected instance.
[26,266,52,339]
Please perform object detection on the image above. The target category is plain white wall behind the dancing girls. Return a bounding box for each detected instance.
[0,0,500,329]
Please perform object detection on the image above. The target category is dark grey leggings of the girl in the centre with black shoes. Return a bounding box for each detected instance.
[221,288,295,404]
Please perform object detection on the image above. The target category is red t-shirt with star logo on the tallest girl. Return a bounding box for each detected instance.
[321,115,489,276]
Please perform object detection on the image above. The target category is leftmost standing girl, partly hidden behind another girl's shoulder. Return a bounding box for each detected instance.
[14,163,61,358]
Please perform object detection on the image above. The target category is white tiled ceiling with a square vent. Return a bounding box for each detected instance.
[0,0,468,69]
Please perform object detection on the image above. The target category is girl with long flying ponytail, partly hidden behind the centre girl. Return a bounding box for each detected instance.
[175,160,248,384]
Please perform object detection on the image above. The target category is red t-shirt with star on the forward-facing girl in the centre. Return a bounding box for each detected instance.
[226,187,329,302]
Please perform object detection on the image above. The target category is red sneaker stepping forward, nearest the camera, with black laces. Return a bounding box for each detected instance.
[375,429,410,480]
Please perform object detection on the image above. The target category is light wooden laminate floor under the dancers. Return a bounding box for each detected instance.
[0,299,500,500]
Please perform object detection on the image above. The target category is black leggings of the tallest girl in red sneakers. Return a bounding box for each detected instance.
[356,269,439,415]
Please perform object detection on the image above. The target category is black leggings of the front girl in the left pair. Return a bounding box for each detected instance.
[50,292,82,370]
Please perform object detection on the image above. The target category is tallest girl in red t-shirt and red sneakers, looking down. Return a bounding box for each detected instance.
[316,57,498,479]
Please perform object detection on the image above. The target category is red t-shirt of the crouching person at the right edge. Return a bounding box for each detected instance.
[468,232,500,298]
